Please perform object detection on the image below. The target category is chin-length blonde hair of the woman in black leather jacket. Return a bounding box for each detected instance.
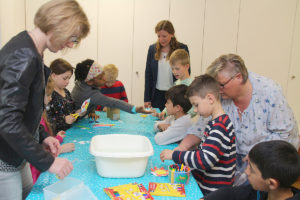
[34,0,90,48]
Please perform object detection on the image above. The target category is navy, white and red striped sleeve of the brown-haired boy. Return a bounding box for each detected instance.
[172,122,233,171]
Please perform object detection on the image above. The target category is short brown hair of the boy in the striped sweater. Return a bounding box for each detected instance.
[186,74,220,100]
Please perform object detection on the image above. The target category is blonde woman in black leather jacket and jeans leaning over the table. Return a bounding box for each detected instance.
[0,0,90,200]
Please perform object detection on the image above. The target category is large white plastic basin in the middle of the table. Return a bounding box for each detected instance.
[90,134,153,178]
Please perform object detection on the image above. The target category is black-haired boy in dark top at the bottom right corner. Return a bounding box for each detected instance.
[204,140,300,200]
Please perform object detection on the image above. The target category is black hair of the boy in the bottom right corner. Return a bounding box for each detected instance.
[249,140,300,188]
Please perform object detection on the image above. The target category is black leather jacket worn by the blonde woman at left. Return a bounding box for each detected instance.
[0,31,54,171]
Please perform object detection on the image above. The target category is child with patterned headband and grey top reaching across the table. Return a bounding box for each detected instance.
[71,59,152,114]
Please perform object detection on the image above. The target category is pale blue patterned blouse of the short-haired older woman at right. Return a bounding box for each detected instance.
[187,72,299,155]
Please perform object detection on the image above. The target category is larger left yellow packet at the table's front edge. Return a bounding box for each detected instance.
[104,183,153,200]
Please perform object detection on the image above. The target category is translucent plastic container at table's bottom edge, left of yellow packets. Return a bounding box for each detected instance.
[43,177,97,200]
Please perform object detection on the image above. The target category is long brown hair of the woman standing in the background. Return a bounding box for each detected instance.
[155,20,180,60]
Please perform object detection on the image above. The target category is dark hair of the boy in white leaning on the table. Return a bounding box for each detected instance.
[166,85,192,113]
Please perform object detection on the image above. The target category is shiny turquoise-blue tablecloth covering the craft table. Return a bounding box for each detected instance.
[27,111,203,200]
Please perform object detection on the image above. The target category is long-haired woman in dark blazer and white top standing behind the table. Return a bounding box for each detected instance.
[144,20,190,110]
